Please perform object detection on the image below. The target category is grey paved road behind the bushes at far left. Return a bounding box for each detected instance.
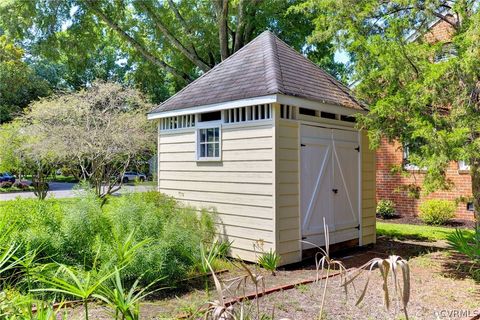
[0,182,155,201]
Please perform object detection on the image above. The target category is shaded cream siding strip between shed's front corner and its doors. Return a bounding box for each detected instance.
[275,110,301,264]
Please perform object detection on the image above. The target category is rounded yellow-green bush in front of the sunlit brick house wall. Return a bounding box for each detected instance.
[419,199,457,225]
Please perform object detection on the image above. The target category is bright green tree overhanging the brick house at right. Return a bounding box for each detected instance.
[297,0,480,222]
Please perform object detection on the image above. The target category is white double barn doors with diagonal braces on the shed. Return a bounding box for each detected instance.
[301,125,360,249]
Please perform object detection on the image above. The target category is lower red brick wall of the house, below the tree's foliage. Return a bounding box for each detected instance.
[377,141,474,220]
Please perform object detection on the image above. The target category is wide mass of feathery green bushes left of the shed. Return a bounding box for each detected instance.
[0,191,214,285]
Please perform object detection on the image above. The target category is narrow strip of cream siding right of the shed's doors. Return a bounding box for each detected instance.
[361,131,377,245]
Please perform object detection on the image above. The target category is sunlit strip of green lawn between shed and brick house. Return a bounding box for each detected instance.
[377,221,473,241]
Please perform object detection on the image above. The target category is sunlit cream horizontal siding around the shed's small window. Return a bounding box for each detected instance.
[158,122,275,261]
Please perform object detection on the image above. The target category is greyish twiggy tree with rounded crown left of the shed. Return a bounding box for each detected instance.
[21,82,155,197]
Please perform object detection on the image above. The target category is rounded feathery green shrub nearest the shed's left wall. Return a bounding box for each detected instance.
[105,191,214,283]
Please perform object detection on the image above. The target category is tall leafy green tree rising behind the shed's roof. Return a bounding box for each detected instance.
[0,0,343,102]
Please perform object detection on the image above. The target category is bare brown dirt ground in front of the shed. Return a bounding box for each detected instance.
[69,238,480,320]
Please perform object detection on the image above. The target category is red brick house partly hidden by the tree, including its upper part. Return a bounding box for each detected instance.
[377,16,474,219]
